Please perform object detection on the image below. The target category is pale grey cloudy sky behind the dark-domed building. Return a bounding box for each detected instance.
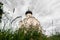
[0,0,60,35]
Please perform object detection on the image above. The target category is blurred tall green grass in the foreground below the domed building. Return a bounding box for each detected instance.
[0,27,60,40]
